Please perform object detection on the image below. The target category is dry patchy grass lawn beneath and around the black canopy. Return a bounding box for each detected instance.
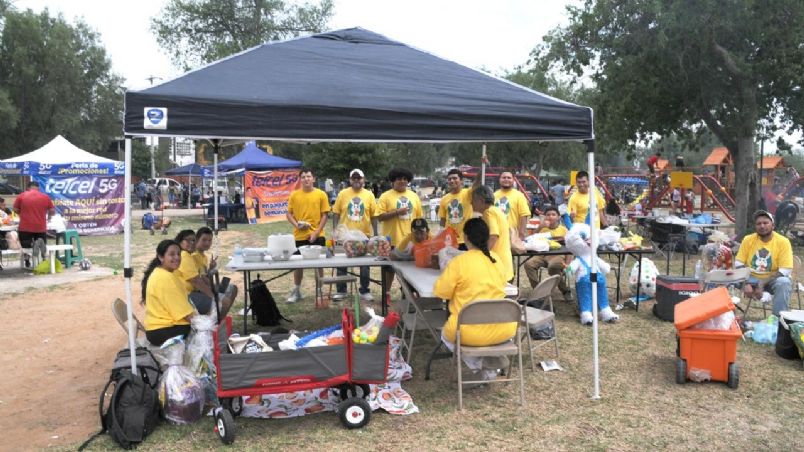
[72,217,804,451]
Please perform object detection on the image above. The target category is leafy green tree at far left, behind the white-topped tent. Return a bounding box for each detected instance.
[0,3,123,158]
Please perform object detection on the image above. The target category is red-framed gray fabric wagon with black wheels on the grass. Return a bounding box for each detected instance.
[213,309,389,444]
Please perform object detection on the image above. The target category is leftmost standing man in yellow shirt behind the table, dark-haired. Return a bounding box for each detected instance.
[287,168,330,303]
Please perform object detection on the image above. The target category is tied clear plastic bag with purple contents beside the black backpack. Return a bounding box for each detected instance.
[159,337,205,425]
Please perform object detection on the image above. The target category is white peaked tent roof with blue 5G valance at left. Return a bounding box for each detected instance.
[0,135,125,176]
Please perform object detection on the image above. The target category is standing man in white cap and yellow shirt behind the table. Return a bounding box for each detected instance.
[332,168,377,301]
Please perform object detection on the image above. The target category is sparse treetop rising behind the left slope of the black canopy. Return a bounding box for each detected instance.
[151,0,333,70]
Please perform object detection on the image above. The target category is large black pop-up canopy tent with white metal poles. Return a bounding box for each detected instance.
[124,28,598,396]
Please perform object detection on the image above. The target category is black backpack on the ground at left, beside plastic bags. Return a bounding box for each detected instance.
[78,347,162,450]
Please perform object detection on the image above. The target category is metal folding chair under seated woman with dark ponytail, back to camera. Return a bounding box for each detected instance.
[455,299,525,410]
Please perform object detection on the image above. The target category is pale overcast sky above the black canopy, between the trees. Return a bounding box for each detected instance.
[12,0,576,89]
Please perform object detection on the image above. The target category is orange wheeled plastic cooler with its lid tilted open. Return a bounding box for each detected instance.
[674,287,742,388]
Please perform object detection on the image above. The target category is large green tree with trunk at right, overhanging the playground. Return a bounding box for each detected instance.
[535,0,804,237]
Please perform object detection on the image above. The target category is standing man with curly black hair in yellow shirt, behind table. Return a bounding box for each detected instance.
[377,168,424,246]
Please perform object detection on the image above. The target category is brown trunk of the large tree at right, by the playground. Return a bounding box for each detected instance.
[729,136,757,237]
